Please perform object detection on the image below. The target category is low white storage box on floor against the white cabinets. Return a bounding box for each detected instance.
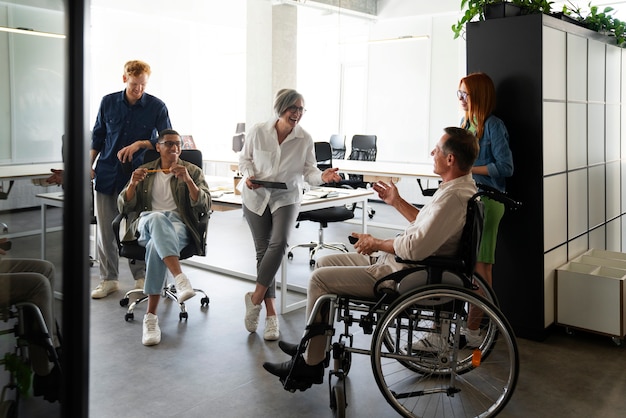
[556,249,626,339]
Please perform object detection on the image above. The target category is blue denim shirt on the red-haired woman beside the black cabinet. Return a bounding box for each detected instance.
[460,115,513,192]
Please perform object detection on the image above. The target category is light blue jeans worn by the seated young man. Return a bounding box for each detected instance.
[137,211,190,295]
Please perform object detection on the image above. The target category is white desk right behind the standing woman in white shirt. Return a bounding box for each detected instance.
[197,187,373,313]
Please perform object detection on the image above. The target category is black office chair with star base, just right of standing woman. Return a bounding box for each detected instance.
[287,142,354,267]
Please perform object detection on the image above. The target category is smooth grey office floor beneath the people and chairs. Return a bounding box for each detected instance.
[3,202,626,418]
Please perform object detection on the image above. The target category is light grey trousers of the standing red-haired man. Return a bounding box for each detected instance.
[96,192,146,280]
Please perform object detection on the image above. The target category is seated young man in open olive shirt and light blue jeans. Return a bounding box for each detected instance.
[118,129,211,345]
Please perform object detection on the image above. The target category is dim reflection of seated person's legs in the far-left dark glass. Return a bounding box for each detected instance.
[0,238,61,402]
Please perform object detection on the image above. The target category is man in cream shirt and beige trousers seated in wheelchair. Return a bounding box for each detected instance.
[263,127,478,389]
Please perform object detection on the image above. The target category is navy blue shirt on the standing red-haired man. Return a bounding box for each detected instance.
[91,90,172,195]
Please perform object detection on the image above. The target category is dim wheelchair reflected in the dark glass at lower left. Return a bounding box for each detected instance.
[0,302,62,418]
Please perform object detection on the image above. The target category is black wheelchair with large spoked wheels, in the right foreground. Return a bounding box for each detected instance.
[281,188,520,417]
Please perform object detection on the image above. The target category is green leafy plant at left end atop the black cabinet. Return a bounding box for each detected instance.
[452,0,551,39]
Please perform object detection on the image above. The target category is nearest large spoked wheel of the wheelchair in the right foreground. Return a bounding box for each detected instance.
[371,285,519,417]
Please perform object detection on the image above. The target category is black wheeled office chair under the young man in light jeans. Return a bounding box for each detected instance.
[112,149,210,321]
